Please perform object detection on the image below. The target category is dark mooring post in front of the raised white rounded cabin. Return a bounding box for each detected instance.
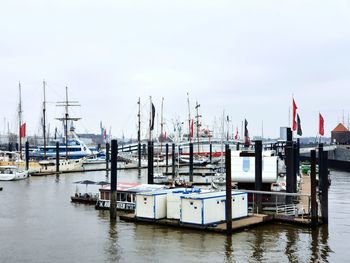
[254,140,262,214]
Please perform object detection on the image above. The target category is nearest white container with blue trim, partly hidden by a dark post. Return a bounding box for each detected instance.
[180,191,248,225]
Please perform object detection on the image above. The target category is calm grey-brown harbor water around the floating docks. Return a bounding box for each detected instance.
[0,171,350,263]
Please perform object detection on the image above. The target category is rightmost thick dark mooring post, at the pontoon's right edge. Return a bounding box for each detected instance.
[319,151,329,224]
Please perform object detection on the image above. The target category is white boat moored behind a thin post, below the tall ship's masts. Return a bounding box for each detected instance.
[39,158,84,173]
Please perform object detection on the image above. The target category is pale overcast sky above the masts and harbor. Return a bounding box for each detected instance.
[0,0,350,138]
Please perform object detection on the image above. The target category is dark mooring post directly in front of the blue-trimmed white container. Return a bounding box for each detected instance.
[225,144,232,234]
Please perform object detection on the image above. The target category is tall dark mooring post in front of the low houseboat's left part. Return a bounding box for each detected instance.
[109,140,118,221]
